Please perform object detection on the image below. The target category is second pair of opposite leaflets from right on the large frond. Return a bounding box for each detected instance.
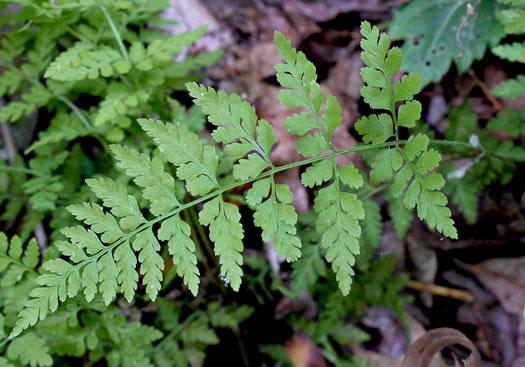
[275,32,364,294]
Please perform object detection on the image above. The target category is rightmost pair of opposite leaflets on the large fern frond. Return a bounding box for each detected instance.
[356,22,457,238]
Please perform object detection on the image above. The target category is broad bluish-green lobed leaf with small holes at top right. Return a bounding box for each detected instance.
[389,0,505,87]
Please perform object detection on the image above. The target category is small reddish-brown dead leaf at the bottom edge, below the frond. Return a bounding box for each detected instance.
[286,333,327,367]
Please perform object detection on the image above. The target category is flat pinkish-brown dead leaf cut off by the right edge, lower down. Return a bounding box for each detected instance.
[466,257,525,315]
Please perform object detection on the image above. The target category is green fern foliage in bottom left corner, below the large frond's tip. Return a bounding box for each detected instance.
[0,233,253,367]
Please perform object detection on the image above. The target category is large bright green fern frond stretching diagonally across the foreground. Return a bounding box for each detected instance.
[11,22,458,337]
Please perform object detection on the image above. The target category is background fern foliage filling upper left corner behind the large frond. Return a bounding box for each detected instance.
[0,0,221,238]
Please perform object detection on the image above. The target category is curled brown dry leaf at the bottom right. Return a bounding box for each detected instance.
[401,328,481,367]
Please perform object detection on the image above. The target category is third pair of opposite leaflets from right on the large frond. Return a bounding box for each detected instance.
[187,83,301,261]
